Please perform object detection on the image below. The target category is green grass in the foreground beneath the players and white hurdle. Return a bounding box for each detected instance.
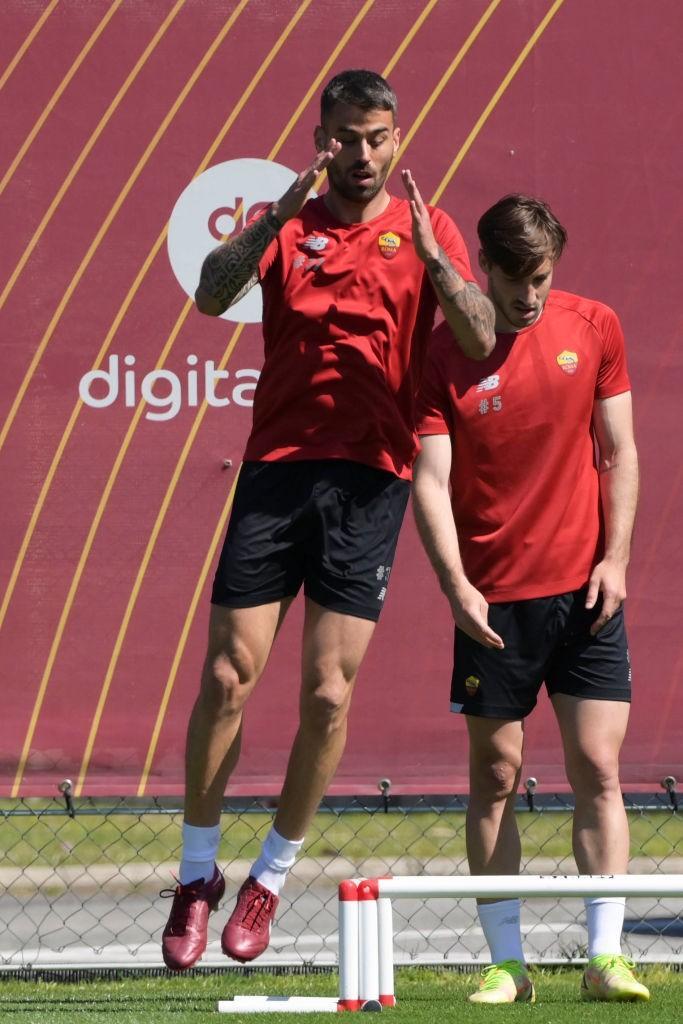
[0,967,683,1024]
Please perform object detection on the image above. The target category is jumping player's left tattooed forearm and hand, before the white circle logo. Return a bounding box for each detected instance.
[195,139,341,316]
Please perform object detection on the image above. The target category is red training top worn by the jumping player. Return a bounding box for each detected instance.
[245,198,473,479]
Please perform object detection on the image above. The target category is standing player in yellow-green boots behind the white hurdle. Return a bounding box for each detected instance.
[414,196,649,1002]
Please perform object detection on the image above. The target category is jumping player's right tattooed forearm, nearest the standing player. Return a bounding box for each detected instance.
[426,246,496,358]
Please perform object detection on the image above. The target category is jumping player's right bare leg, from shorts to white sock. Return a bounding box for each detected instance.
[274,599,375,840]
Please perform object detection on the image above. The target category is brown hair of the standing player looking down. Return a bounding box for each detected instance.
[477,193,567,278]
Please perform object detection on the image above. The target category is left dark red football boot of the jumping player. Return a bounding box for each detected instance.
[161,867,225,971]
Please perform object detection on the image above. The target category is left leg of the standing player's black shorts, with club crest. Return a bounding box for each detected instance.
[451,598,554,719]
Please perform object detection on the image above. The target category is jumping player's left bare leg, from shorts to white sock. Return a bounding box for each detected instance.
[185,598,292,827]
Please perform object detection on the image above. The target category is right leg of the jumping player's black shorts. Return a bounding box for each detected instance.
[304,459,410,622]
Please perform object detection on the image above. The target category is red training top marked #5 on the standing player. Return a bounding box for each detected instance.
[418,291,631,602]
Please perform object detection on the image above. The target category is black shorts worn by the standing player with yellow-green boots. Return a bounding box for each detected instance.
[451,587,631,719]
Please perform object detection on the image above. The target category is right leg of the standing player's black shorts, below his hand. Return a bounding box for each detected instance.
[546,590,631,702]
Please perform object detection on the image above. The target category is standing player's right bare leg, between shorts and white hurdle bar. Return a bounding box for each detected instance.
[552,693,630,874]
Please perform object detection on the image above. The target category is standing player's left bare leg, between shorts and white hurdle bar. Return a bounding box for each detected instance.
[466,716,524,880]
